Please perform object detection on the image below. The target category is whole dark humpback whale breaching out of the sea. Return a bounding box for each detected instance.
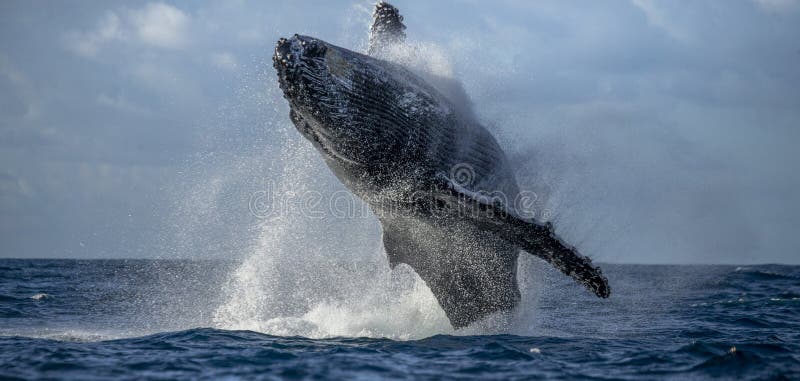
[273,2,610,328]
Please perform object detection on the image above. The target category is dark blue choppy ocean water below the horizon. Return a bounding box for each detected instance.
[0,259,800,380]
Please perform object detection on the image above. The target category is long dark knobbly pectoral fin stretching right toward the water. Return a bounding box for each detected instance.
[425,178,611,298]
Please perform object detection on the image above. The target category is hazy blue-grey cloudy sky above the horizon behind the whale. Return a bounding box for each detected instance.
[0,0,800,264]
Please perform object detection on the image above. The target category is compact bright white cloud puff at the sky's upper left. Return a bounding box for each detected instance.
[131,3,189,48]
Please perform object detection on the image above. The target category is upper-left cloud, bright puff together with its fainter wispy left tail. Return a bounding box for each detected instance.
[64,3,190,58]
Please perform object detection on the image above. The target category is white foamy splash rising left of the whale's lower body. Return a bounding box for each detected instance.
[214,138,462,339]
